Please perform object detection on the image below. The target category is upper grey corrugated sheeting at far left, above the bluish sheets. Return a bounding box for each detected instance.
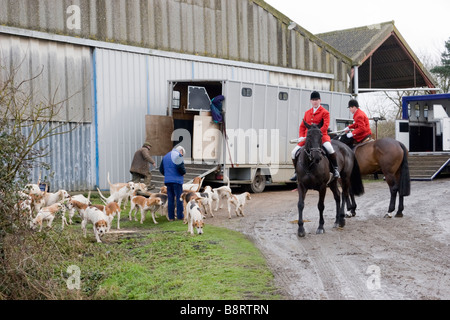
[0,33,92,122]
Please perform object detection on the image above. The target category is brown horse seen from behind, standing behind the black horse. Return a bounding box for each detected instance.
[339,135,411,218]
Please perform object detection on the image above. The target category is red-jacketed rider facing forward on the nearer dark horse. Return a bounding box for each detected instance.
[291,91,340,181]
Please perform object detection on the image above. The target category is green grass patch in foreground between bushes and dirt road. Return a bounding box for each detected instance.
[52,198,282,300]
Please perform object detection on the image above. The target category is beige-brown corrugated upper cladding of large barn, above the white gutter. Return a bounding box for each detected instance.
[0,0,352,92]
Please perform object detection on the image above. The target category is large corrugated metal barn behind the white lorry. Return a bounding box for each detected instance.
[0,0,352,191]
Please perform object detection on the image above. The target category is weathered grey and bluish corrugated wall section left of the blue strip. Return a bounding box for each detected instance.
[0,33,94,191]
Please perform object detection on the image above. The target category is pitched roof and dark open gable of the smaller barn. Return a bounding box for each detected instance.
[317,21,436,89]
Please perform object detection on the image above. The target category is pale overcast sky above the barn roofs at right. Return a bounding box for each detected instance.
[265,0,450,57]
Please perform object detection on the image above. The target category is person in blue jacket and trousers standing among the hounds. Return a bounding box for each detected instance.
[159,147,186,221]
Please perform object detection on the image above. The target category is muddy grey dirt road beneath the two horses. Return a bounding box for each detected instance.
[206,179,450,300]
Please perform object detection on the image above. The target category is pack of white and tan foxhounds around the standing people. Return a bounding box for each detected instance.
[16,173,251,242]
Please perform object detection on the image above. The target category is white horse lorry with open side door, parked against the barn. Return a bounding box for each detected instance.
[146,80,353,193]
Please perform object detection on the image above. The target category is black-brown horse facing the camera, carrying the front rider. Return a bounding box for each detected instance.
[295,122,364,237]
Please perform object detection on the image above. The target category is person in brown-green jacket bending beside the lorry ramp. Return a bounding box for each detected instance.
[130,142,156,190]
